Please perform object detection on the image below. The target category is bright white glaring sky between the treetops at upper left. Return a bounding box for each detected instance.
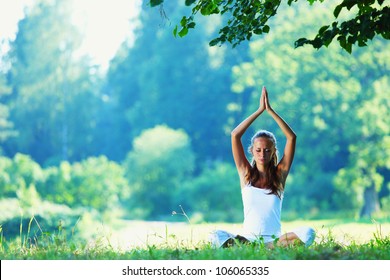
[0,0,142,69]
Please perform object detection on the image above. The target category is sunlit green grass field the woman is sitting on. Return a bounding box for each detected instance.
[0,219,390,260]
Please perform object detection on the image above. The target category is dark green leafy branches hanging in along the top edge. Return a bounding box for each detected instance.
[150,0,390,53]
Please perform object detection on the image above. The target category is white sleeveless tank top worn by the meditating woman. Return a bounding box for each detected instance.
[241,184,283,241]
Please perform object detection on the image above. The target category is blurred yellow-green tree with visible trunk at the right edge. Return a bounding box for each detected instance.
[335,76,390,217]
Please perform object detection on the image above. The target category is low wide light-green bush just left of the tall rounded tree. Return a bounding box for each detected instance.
[37,156,129,213]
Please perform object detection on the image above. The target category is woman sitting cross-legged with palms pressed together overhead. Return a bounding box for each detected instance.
[211,87,315,248]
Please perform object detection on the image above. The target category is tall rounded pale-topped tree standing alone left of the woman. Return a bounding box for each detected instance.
[123,126,195,219]
